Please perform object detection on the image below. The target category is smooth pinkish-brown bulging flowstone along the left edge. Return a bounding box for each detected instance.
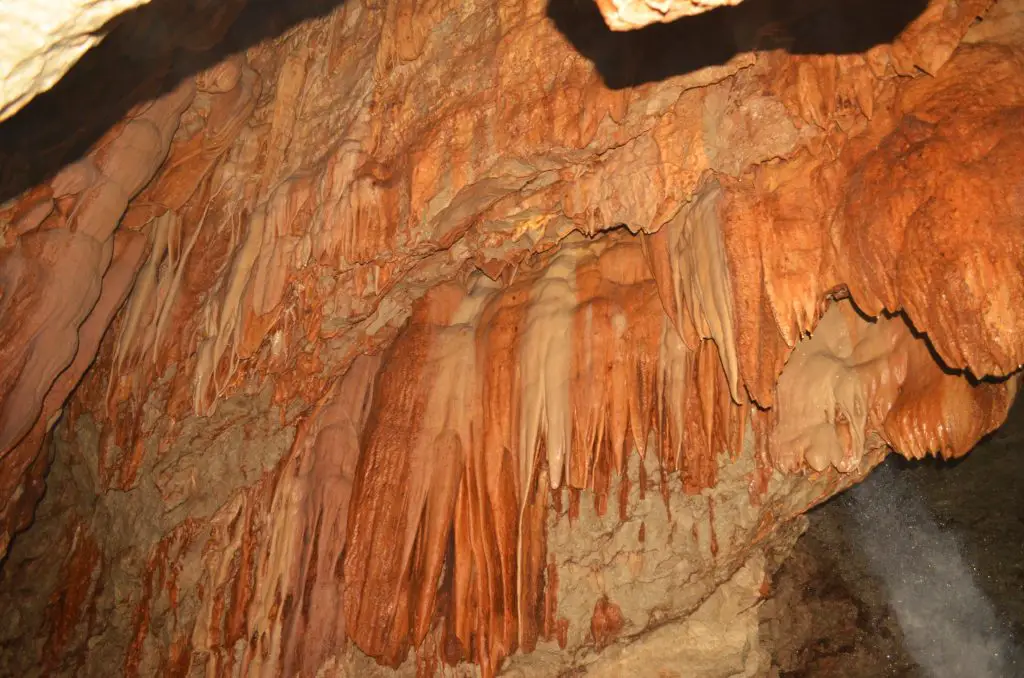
[0,83,193,552]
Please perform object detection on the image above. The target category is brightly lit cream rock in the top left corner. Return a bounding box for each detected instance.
[0,0,150,120]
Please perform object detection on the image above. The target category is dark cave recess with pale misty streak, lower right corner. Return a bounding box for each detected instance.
[761,397,1024,678]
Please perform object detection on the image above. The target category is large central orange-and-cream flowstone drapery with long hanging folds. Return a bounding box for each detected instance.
[345,236,761,675]
